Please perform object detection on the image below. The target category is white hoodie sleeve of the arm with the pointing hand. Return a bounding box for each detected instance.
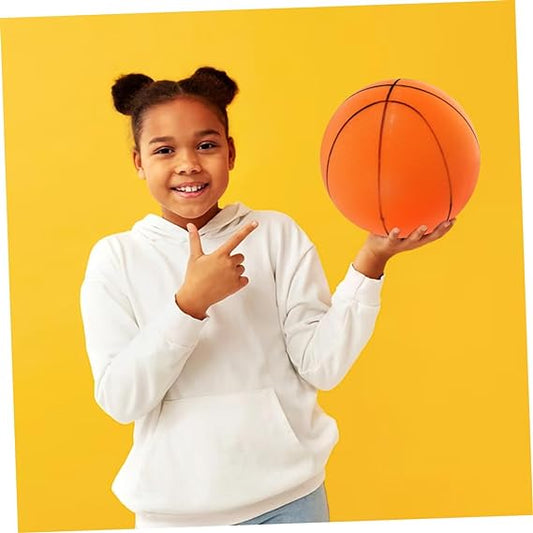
[81,239,208,424]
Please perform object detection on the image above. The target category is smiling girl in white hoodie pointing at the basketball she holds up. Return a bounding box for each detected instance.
[81,67,452,528]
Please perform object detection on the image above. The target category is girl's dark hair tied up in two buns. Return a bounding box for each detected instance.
[111,67,239,150]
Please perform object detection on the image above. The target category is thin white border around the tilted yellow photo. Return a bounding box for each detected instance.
[0,0,533,533]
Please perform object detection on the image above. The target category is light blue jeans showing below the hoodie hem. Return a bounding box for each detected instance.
[237,484,329,525]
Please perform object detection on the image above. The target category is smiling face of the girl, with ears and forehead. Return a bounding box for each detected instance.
[133,97,235,228]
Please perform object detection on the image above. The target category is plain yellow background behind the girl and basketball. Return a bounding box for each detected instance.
[0,1,531,531]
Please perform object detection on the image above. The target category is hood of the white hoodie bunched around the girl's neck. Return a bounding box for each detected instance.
[132,203,252,241]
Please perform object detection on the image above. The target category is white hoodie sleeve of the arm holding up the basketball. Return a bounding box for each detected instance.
[276,220,383,390]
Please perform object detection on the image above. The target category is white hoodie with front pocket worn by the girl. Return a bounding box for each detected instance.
[81,204,382,527]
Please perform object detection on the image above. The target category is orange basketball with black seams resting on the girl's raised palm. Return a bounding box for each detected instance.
[320,79,480,237]
